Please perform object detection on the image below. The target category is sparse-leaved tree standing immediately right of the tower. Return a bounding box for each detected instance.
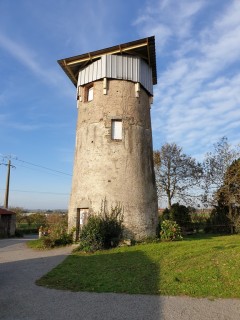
[153,143,202,209]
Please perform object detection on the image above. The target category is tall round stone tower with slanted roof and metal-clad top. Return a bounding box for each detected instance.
[58,37,158,239]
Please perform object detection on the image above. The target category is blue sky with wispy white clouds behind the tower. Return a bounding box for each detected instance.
[0,0,240,209]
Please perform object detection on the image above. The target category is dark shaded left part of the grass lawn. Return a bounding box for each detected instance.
[37,251,160,294]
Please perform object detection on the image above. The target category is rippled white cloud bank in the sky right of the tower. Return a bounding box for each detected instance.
[135,1,240,158]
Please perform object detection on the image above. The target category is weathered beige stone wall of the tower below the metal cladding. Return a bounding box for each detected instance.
[69,79,157,239]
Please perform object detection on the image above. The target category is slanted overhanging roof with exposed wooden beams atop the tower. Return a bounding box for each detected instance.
[58,36,157,86]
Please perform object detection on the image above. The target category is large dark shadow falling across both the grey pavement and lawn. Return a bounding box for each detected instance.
[0,244,163,320]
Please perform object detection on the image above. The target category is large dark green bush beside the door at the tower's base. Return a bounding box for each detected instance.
[78,204,123,252]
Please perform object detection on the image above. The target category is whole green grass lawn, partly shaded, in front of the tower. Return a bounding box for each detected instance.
[37,235,240,298]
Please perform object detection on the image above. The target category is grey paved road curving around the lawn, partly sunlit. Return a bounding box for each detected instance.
[0,238,240,320]
